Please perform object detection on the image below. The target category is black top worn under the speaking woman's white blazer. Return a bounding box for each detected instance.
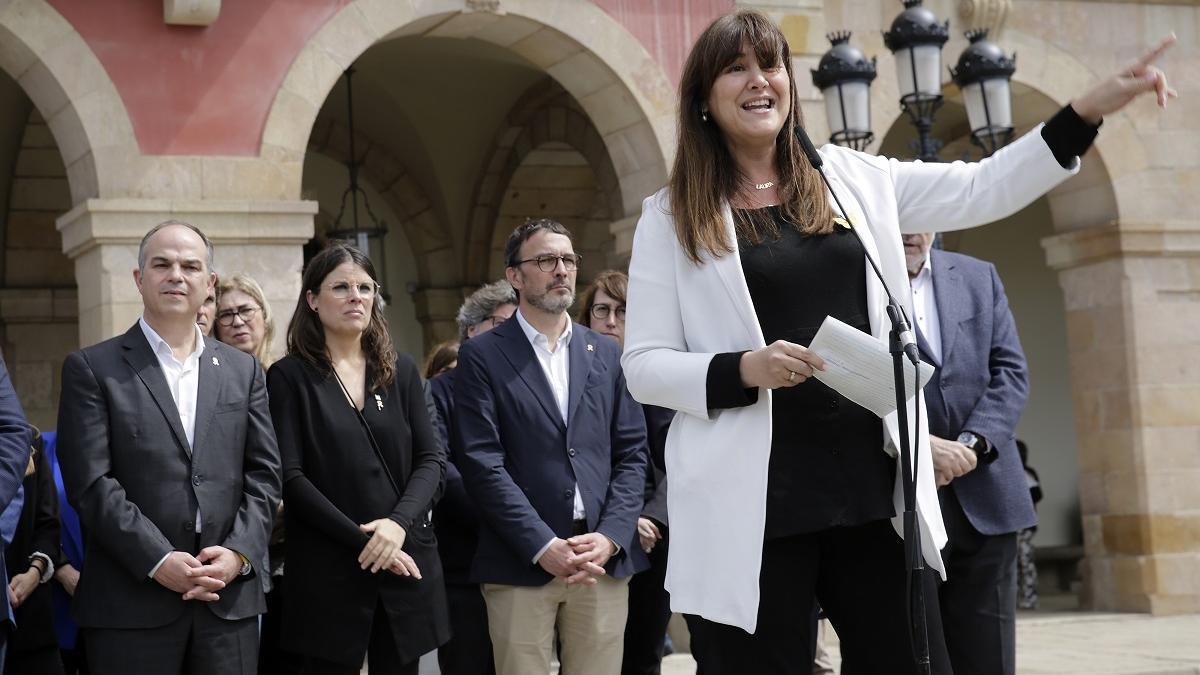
[725,214,895,538]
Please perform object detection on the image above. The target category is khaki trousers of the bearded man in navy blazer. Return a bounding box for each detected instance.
[482,577,629,675]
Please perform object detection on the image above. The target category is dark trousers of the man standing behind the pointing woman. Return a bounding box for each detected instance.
[937,488,1018,675]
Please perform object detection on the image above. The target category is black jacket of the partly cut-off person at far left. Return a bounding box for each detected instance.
[5,443,60,655]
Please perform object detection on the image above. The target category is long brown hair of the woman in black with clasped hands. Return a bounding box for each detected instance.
[288,241,396,390]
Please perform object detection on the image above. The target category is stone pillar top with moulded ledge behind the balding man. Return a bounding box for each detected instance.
[58,199,317,354]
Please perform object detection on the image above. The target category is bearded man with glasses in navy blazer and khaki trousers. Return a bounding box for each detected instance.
[451,220,648,675]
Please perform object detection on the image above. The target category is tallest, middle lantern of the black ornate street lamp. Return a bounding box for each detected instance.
[883,0,950,162]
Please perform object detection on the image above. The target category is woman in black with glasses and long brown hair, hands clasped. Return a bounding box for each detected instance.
[268,243,450,675]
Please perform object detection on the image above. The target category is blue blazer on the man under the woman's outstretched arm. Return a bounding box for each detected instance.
[920,250,1037,534]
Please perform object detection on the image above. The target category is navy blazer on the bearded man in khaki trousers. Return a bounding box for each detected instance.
[451,319,649,586]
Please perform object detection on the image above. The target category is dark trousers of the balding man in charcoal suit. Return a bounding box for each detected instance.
[83,601,258,675]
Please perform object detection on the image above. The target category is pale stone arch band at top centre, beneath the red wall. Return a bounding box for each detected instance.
[260,0,674,228]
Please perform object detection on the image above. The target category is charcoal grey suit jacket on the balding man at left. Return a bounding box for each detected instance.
[58,324,281,628]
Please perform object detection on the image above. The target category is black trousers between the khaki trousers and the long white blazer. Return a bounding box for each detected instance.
[620,527,671,675]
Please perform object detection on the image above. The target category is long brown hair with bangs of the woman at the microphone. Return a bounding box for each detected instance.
[667,10,833,264]
